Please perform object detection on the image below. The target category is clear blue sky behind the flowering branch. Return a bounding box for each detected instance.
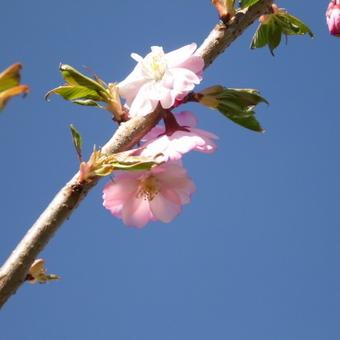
[0,0,340,340]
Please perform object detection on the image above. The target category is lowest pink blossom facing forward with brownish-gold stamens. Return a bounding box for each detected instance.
[103,162,195,228]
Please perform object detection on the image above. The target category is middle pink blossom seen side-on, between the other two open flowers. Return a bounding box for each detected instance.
[142,111,218,160]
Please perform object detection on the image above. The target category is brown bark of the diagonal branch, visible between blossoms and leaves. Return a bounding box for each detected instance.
[0,0,272,308]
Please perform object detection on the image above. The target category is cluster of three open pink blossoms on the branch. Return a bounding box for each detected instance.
[103,43,217,228]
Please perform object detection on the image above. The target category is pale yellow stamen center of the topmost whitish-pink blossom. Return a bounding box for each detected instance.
[142,46,168,81]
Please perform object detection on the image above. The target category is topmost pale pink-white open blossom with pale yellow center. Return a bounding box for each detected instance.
[118,43,204,117]
